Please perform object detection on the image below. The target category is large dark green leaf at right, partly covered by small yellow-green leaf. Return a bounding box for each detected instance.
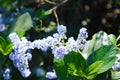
[87,45,116,73]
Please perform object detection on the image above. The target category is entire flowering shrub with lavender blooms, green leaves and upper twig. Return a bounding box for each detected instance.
[0,0,120,80]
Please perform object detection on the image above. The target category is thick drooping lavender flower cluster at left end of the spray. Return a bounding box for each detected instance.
[9,33,33,77]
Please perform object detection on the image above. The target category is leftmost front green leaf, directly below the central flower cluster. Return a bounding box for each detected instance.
[54,59,67,80]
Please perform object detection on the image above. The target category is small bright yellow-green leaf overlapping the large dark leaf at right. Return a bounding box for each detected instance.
[84,61,103,79]
